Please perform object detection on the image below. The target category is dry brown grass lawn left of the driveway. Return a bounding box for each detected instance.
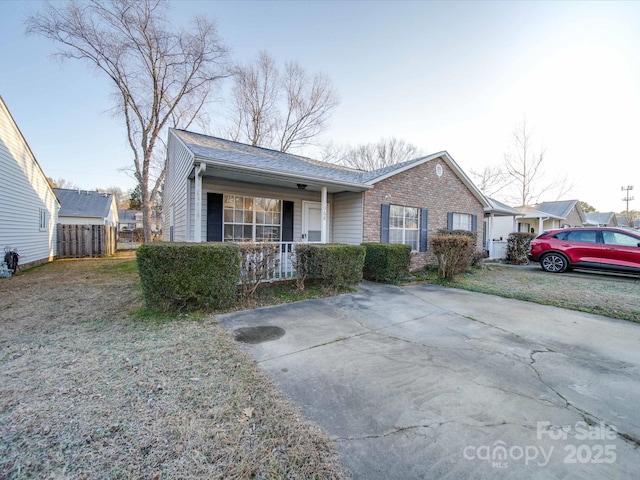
[0,252,345,479]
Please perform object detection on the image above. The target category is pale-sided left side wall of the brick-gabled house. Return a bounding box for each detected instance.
[162,132,194,242]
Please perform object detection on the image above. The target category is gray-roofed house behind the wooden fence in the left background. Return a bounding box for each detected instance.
[54,188,118,227]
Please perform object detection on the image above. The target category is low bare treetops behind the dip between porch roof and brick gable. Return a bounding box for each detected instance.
[322,137,422,171]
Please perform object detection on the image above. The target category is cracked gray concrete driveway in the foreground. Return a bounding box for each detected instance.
[217,282,640,480]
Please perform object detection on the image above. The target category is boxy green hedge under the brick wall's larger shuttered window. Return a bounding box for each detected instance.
[362,243,411,284]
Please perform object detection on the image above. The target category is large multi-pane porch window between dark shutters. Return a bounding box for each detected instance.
[224,195,282,242]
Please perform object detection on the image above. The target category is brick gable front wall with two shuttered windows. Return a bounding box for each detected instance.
[363,158,484,270]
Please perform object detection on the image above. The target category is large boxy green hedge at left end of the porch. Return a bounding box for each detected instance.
[137,243,240,312]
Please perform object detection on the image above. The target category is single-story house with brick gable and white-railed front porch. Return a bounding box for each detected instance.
[163,129,489,269]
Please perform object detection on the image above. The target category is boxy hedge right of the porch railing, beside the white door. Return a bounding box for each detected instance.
[296,243,365,289]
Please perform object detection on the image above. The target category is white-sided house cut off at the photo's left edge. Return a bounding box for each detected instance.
[0,97,60,265]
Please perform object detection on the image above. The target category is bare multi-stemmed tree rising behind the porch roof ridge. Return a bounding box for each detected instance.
[229,52,339,152]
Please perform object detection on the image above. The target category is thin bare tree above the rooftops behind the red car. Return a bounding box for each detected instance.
[504,118,573,205]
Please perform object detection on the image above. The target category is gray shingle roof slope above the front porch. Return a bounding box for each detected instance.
[173,129,370,186]
